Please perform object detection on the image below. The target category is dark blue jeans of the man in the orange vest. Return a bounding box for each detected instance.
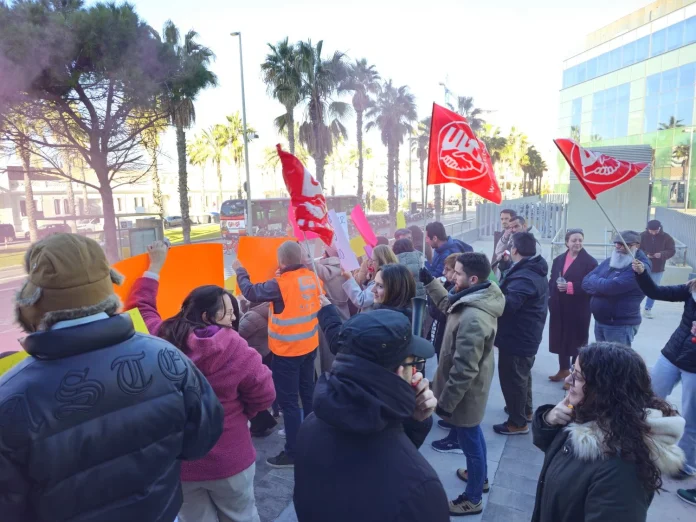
[271,350,317,457]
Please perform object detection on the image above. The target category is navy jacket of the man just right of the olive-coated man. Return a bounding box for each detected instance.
[495,256,549,357]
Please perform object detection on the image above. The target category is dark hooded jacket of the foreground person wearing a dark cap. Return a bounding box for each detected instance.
[294,353,449,522]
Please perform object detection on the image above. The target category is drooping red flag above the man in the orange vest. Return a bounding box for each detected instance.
[276,145,334,246]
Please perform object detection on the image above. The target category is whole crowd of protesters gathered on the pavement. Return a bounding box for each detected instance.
[0,209,696,522]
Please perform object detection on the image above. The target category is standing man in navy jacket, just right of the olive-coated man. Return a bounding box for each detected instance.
[493,232,549,435]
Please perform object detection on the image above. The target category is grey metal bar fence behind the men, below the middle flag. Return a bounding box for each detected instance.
[476,194,568,239]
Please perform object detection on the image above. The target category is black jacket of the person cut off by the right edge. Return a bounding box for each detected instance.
[636,270,696,373]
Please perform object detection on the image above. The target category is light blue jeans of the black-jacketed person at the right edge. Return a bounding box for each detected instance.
[650,355,696,469]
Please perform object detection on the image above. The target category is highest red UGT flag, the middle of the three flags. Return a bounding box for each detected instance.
[428,103,503,204]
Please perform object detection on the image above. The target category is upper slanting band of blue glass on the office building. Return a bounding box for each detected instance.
[563,16,696,89]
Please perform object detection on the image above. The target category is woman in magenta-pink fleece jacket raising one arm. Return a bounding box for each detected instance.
[126,241,275,522]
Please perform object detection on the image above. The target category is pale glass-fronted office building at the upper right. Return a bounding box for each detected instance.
[558,0,696,208]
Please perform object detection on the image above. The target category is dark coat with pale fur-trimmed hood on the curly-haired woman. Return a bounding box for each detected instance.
[532,405,685,522]
